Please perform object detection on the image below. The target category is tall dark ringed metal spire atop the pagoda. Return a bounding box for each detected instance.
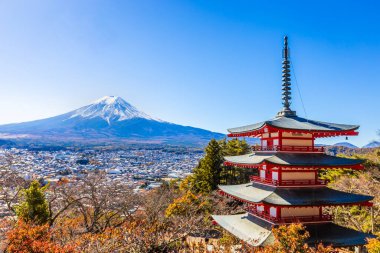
[277,36,296,116]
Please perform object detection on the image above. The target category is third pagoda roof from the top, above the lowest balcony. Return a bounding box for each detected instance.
[219,182,373,206]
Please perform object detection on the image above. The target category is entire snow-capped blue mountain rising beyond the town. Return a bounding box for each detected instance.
[0,96,224,145]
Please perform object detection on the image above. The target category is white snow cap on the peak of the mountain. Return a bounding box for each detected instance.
[70,96,162,125]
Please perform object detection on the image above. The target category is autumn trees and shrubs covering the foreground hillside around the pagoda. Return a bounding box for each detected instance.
[0,139,380,253]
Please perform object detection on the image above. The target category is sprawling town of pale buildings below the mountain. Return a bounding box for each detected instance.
[0,144,203,188]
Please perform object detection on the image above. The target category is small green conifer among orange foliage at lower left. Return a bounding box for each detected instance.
[16,180,50,225]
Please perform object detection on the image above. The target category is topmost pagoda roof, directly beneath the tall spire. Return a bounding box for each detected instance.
[227,116,359,137]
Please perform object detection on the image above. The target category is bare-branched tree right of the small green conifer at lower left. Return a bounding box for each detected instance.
[48,172,141,233]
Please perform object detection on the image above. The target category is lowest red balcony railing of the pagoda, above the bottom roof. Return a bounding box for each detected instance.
[247,207,334,224]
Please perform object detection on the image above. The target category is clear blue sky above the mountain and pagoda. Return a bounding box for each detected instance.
[0,0,380,145]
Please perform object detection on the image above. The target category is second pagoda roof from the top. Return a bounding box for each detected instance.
[224,152,363,168]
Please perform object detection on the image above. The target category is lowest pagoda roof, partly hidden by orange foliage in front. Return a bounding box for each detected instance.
[212,213,375,247]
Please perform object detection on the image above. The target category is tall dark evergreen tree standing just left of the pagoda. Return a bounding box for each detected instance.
[192,139,223,193]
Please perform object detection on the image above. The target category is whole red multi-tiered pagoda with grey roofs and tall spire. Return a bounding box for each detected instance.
[213,37,373,250]
